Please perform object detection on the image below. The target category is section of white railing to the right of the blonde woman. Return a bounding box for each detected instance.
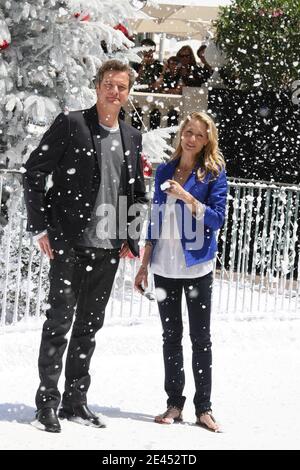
[215,180,300,318]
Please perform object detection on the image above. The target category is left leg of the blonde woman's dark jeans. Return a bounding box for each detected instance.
[154,274,185,408]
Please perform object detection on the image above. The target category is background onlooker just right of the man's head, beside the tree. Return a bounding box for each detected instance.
[132,39,163,93]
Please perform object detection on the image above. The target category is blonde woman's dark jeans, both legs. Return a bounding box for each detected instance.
[154,273,212,415]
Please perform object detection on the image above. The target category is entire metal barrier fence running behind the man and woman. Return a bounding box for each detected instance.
[0,170,300,326]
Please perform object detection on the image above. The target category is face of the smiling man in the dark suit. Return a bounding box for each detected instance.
[96,71,129,109]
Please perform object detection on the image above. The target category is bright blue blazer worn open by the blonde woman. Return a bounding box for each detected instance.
[147,160,227,266]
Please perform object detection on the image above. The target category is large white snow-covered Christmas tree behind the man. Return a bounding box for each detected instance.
[0,0,155,322]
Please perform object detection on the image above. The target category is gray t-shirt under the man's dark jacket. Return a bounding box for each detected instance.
[79,124,124,249]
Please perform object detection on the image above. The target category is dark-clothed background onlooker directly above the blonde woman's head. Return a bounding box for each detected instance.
[177,46,213,87]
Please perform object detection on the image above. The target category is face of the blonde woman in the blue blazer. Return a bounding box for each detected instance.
[181,119,208,156]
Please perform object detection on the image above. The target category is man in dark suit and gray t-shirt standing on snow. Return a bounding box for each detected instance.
[23,60,147,432]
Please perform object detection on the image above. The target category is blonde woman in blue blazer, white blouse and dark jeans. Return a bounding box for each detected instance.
[135,112,227,432]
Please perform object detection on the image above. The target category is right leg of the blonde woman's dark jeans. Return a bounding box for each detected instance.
[184,273,213,415]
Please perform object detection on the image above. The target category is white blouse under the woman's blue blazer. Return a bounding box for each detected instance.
[150,195,213,279]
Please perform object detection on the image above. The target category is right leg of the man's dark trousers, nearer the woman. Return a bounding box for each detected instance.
[63,248,119,406]
